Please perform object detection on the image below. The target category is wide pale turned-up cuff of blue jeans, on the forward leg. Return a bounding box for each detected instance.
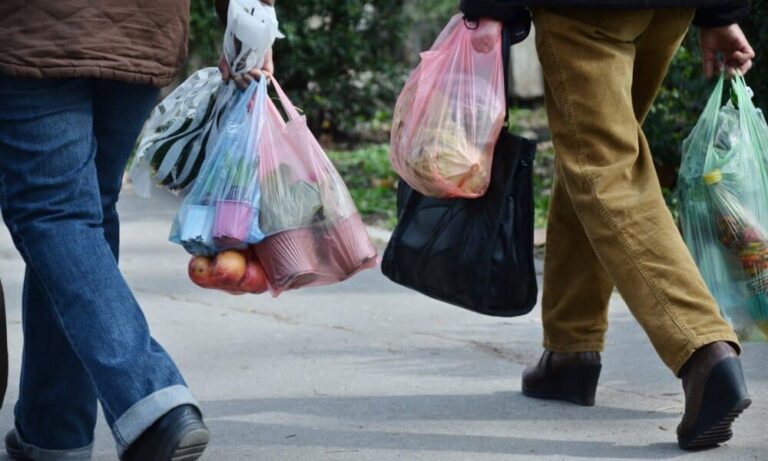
[112,384,200,457]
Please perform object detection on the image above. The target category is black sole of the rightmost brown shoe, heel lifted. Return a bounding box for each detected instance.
[677,358,752,450]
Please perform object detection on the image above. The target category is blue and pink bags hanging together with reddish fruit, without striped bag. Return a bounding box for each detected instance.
[171,76,377,296]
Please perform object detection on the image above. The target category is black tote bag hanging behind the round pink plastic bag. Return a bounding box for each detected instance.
[381,130,538,317]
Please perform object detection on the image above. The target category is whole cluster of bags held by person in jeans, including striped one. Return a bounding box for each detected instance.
[130,0,377,296]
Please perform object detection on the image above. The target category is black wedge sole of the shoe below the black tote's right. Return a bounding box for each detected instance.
[523,364,602,407]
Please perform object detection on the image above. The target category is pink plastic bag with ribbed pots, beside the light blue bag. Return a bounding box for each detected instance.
[253,79,377,296]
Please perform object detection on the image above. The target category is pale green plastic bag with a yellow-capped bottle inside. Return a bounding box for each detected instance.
[677,75,768,340]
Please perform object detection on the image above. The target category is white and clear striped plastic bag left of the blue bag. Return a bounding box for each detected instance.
[129,67,235,197]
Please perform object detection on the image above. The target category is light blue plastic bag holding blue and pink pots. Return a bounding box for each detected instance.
[170,77,267,256]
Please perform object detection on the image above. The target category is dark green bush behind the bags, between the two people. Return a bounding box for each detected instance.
[186,0,458,141]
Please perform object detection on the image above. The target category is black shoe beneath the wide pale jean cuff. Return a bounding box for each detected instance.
[121,405,210,461]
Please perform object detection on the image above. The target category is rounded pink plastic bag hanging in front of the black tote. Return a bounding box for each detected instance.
[390,15,506,198]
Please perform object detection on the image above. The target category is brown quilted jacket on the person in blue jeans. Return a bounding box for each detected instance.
[0,0,189,86]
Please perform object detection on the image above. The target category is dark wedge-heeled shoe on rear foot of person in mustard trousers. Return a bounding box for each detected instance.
[523,350,602,406]
